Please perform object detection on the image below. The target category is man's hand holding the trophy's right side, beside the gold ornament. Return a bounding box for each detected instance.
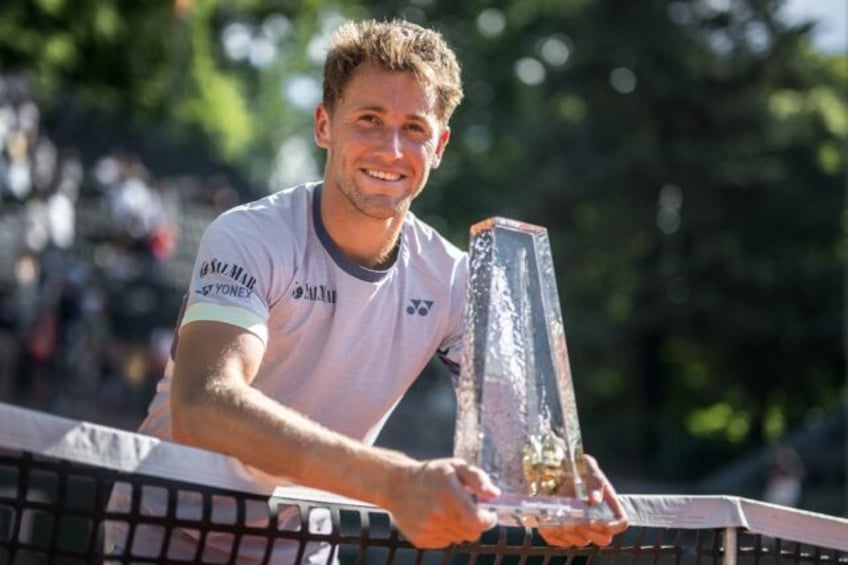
[539,455,627,547]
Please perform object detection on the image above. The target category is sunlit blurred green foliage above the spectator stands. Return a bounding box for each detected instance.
[0,0,254,159]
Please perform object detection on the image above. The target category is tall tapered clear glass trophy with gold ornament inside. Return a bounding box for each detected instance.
[454,218,613,527]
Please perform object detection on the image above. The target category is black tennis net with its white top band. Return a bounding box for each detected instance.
[0,398,848,565]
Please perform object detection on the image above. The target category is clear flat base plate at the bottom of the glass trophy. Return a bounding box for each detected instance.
[477,494,615,528]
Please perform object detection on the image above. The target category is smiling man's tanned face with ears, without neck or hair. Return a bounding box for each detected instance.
[315,63,450,219]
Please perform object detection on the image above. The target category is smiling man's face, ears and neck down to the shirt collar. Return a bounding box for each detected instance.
[315,59,450,268]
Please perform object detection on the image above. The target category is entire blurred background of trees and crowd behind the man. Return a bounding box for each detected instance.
[0,0,848,515]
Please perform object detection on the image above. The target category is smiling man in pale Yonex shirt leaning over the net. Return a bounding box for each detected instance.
[106,16,626,560]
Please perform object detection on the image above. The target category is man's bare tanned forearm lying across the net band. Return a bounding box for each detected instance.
[171,372,416,506]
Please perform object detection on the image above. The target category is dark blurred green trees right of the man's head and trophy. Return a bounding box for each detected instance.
[350,0,848,479]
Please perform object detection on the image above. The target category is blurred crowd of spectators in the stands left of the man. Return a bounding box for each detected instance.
[0,69,239,427]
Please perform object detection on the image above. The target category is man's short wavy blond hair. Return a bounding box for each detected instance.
[323,20,462,125]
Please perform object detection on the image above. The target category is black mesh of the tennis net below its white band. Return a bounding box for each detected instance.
[0,449,848,565]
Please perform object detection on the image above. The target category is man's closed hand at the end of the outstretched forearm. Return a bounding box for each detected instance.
[385,459,500,549]
